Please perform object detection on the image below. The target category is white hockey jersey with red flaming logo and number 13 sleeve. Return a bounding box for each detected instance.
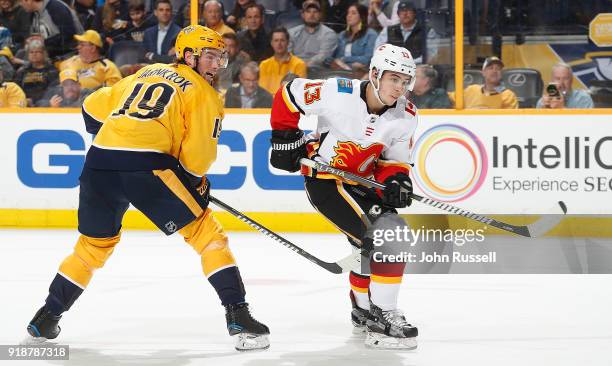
[271,78,418,181]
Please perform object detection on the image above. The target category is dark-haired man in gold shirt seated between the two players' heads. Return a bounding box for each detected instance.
[259,27,306,95]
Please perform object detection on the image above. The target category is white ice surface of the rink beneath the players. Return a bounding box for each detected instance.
[0,230,612,366]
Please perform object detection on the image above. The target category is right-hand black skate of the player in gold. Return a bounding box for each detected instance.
[225,302,270,351]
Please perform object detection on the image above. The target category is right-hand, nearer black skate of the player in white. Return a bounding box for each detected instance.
[365,303,419,350]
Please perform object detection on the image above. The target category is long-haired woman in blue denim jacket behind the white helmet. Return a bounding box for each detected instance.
[331,4,377,78]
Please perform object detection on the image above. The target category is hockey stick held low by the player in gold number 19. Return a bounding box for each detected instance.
[210,196,361,274]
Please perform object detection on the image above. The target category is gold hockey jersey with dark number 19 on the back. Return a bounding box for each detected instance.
[83,64,223,177]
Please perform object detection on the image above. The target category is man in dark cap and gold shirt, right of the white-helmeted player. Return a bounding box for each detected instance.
[450,56,518,109]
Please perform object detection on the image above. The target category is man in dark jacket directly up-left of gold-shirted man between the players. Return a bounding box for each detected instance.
[238,4,274,62]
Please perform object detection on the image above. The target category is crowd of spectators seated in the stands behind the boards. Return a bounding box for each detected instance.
[0,0,593,108]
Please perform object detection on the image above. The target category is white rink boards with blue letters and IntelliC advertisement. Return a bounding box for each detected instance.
[0,114,612,214]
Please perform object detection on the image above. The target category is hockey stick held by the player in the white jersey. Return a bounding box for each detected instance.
[300,158,567,238]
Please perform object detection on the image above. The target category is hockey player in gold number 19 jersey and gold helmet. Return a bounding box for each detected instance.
[28,25,269,350]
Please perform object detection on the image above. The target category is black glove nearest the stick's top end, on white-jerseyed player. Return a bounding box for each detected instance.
[270,129,308,172]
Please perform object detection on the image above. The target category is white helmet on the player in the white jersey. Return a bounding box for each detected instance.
[368,43,416,104]
